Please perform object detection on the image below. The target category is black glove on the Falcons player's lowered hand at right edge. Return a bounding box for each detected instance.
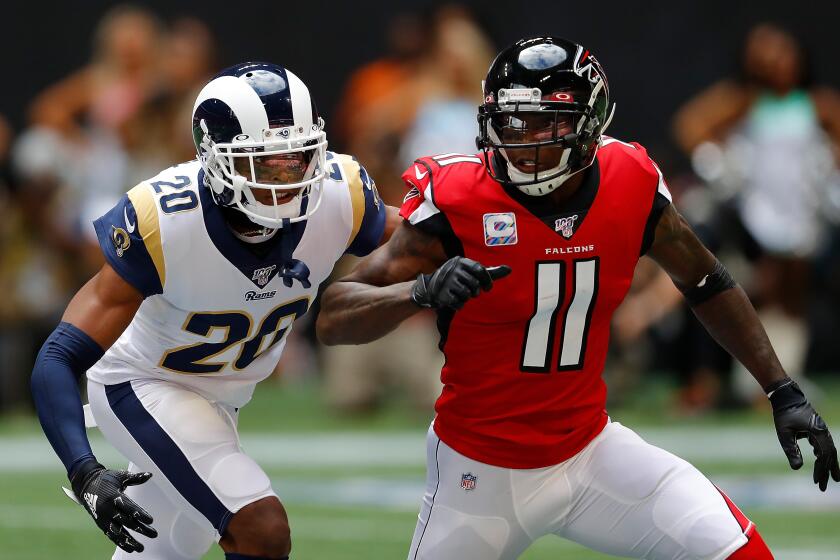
[767,379,840,492]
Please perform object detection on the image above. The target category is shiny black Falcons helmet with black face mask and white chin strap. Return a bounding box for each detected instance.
[476,37,615,195]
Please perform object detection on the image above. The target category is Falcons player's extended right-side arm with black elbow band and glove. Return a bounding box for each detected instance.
[648,205,840,490]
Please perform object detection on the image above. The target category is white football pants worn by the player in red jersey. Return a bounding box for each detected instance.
[408,422,750,560]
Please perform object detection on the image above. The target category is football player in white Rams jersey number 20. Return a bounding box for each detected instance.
[32,63,398,560]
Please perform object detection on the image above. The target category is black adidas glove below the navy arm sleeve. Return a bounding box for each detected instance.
[70,461,157,552]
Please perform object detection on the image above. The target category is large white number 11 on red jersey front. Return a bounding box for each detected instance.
[520,257,599,373]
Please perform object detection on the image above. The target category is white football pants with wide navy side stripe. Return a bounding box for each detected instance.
[88,380,275,560]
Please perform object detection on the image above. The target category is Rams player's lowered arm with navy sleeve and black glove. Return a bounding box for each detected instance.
[32,264,157,552]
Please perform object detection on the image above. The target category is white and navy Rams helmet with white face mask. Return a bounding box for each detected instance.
[193,62,327,229]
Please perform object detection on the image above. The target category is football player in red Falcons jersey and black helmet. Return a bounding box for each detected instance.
[318,37,840,560]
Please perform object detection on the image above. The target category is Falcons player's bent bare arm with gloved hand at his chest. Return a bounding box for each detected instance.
[316,222,510,345]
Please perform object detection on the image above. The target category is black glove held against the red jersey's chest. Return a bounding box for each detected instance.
[411,257,510,309]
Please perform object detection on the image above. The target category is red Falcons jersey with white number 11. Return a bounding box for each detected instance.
[400,138,670,468]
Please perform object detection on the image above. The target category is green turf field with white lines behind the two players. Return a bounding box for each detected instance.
[0,383,840,560]
